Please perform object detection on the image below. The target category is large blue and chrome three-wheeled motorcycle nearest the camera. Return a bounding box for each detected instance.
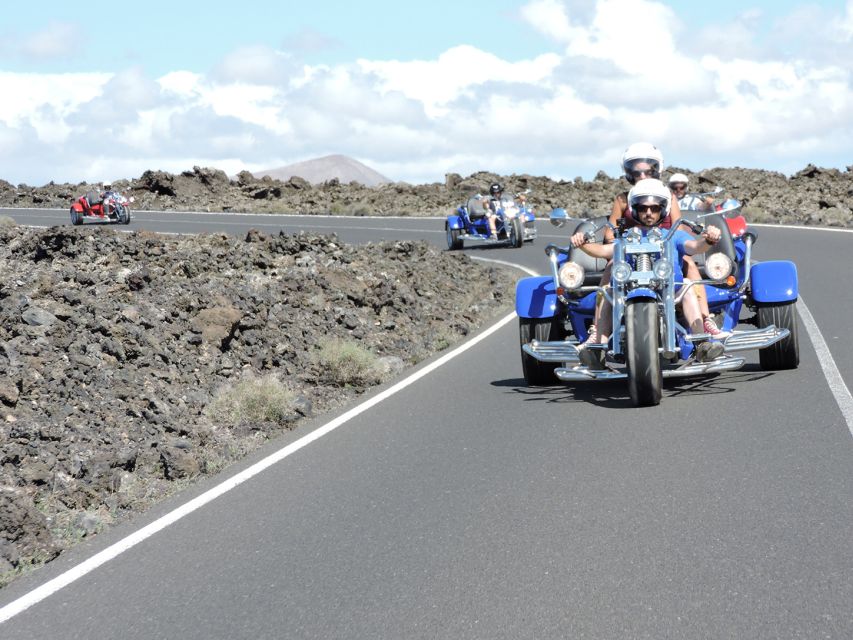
[516,200,799,406]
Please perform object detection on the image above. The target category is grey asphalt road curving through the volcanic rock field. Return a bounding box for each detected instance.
[0,210,853,640]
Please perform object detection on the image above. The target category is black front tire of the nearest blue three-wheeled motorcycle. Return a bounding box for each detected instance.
[625,300,663,407]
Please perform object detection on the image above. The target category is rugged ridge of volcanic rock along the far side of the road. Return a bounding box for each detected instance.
[0,165,853,226]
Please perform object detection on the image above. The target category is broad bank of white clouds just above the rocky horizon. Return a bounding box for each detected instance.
[0,0,853,183]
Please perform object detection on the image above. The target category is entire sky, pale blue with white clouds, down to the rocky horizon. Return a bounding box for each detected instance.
[0,0,853,184]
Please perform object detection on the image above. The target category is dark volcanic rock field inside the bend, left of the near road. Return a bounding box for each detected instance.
[0,222,517,585]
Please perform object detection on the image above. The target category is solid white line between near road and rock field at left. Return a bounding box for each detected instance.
[0,258,530,624]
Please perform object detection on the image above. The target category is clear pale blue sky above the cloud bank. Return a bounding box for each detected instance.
[0,0,824,75]
